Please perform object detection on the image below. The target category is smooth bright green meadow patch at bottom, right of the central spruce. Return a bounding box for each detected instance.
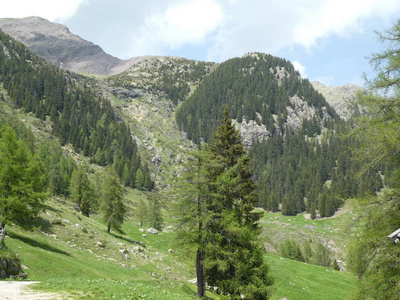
[266,255,357,300]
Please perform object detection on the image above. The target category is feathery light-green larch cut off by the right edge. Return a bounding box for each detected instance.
[348,20,400,299]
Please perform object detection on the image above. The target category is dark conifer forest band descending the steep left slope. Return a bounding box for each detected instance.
[0,32,153,193]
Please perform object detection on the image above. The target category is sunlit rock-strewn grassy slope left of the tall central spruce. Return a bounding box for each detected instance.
[2,195,225,300]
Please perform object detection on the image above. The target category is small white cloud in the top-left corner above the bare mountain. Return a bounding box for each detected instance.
[0,0,85,21]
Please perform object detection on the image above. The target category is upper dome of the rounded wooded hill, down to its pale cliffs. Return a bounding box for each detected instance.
[176,53,337,146]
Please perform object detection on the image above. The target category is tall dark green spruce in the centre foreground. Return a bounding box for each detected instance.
[204,108,270,299]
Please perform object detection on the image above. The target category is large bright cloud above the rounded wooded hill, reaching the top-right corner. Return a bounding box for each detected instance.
[208,0,400,61]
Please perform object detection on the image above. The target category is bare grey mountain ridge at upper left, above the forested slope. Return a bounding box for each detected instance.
[0,17,132,75]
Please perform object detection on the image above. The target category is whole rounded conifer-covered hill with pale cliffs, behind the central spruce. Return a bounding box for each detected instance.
[176,53,382,218]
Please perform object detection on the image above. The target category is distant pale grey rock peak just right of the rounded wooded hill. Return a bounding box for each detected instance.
[311,81,365,120]
